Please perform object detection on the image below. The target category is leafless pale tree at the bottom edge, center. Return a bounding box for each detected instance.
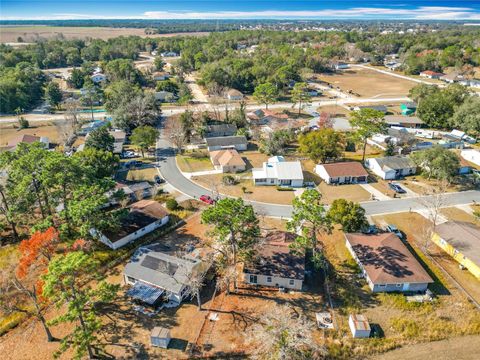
[249,306,325,360]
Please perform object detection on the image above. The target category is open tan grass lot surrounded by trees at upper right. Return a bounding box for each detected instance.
[320,68,415,98]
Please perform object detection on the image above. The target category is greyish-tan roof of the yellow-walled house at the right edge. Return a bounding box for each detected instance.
[435,221,480,265]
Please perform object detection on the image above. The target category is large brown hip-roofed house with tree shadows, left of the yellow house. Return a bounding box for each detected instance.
[345,232,434,292]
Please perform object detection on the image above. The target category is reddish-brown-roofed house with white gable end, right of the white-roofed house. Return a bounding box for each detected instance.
[315,161,368,184]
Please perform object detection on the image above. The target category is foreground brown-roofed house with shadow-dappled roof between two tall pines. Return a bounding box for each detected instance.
[243,231,305,290]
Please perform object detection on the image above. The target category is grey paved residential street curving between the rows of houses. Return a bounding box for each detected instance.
[157,119,480,218]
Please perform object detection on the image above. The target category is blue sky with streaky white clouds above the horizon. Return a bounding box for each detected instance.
[0,0,480,20]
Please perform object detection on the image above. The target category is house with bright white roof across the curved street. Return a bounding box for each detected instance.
[252,156,303,187]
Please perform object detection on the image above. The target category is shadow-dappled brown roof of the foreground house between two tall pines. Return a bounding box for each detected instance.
[243,231,305,280]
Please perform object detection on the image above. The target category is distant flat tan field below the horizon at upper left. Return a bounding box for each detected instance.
[0,26,208,43]
